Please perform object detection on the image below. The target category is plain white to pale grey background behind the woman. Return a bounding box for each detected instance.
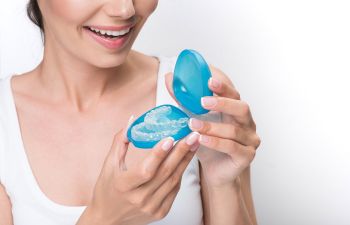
[0,0,350,225]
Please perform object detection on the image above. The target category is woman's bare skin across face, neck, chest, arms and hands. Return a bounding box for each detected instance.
[0,0,260,225]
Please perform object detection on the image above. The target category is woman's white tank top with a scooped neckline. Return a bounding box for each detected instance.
[0,56,203,225]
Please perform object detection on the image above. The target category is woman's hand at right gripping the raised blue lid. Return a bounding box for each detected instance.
[166,68,260,187]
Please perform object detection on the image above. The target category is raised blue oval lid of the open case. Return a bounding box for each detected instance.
[173,49,213,114]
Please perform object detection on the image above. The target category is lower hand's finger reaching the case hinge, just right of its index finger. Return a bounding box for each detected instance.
[140,132,199,194]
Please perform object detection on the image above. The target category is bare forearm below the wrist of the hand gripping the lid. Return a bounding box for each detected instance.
[206,179,253,225]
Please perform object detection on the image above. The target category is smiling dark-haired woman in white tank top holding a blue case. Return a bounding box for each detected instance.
[0,0,260,225]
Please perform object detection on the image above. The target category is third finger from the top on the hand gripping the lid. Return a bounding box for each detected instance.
[188,118,259,146]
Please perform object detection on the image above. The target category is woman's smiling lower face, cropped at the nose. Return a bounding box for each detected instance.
[38,0,158,68]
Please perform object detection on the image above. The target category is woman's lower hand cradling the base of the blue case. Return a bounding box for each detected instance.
[77,118,199,225]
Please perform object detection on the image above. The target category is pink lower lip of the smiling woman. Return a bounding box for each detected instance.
[84,28,133,50]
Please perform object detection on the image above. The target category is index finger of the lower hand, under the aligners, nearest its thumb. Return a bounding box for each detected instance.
[118,137,174,191]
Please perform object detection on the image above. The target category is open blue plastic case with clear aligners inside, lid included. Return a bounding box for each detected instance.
[127,49,213,149]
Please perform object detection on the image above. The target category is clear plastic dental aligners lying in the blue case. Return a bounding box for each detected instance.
[131,106,188,141]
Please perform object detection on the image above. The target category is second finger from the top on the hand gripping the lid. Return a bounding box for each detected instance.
[201,96,254,126]
